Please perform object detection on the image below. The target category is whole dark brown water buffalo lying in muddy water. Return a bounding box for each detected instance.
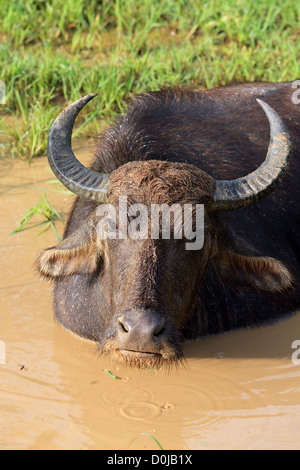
[37,83,300,367]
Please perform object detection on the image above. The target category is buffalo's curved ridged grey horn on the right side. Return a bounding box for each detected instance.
[213,99,292,210]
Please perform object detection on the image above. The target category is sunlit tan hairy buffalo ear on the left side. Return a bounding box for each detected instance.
[35,220,102,279]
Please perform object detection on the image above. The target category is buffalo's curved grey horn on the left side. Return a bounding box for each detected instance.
[47,93,110,203]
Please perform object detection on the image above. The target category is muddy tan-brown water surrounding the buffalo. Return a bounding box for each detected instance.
[0,152,300,450]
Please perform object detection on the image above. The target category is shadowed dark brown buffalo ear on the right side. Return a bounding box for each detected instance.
[214,250,293,293]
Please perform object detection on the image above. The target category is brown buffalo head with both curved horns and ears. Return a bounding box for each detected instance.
[37,95,292,367]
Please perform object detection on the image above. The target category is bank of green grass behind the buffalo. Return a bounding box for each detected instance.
[0,0,300,161]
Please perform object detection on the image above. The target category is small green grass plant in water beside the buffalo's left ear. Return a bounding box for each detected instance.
[11,193,63,241]
